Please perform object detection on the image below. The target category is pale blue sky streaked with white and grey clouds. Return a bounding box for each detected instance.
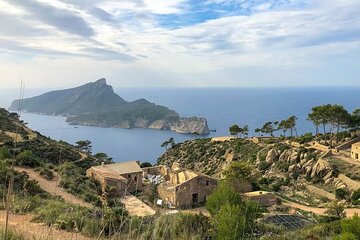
[0,0,360,89]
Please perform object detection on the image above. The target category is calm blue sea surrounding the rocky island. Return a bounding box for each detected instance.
[0,87,360,163]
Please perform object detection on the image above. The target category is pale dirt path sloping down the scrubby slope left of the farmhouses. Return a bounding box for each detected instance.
[15,167,92,208]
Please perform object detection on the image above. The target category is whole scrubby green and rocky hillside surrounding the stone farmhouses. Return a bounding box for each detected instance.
[0,109,360,239]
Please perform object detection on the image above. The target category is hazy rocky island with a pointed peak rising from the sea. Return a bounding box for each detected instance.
[9,78,209,135]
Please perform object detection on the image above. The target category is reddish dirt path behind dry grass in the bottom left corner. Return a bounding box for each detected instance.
[0,211,91,240]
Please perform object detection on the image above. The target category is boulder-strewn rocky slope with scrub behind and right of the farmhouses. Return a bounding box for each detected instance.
[157,138,360,207]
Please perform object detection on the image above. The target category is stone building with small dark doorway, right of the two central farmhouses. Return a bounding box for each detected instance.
[158,163,217,207]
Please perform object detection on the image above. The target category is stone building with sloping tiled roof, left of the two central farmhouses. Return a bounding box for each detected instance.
[86,161,143,194]
